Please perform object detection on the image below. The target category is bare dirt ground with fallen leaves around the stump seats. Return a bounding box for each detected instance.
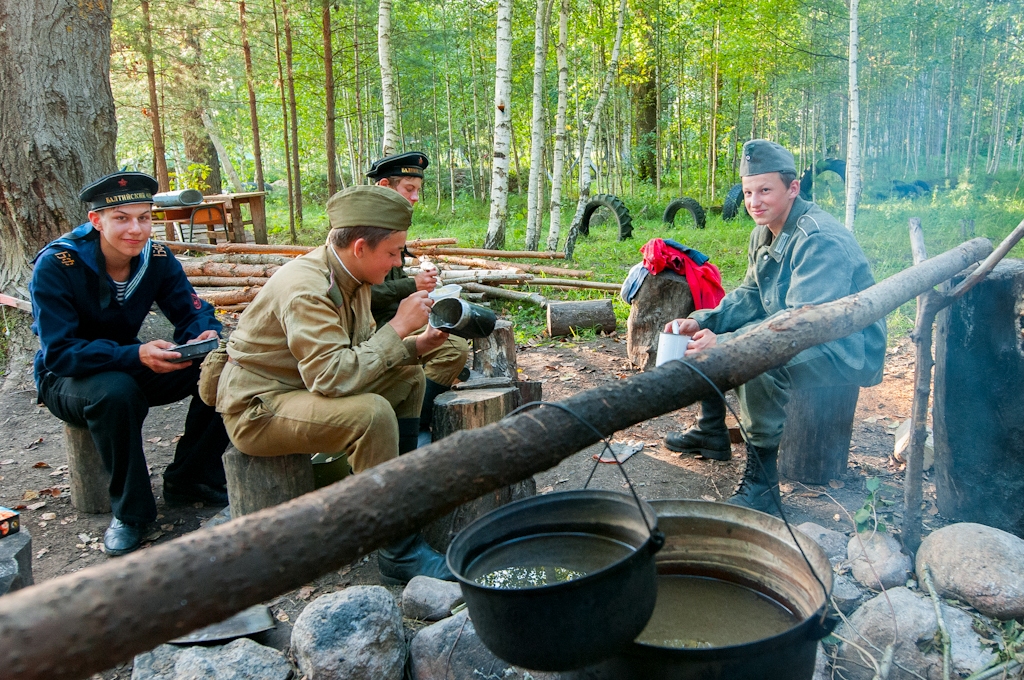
[0,315,941,680]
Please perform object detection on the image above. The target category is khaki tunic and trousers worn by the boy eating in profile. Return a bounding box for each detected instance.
[217,246,424,472]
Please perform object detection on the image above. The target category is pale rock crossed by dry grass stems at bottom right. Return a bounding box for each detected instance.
[836,587,995,680]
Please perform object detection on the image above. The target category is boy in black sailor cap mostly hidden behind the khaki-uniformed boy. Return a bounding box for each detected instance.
[367,152,470,442]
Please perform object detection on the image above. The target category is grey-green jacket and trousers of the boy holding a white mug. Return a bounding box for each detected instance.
[690,197,886,448]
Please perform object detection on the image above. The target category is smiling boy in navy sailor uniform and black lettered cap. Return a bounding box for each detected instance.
[30,172,228,555]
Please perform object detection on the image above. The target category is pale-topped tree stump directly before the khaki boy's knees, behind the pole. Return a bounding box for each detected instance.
[423,387,537,552]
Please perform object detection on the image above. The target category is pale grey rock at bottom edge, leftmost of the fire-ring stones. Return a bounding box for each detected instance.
[131,638,295,680]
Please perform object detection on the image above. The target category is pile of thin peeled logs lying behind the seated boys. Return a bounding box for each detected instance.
[164,239,620,311]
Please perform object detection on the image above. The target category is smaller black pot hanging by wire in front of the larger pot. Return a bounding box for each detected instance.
[447,490,664,671]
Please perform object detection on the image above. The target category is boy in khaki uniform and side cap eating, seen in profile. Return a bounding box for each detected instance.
[217,186,453,583]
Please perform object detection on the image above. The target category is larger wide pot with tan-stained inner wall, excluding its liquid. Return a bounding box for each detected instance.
[565,501,835,680]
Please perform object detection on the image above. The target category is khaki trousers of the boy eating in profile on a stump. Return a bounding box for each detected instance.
[222,366,425,472]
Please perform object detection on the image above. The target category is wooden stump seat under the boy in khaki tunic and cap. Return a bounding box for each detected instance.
[223,445,314,517]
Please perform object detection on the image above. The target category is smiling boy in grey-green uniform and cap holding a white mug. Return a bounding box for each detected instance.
[666,139,886,512]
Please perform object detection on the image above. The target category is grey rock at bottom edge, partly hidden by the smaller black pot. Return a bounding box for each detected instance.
[409,609,558,680]
